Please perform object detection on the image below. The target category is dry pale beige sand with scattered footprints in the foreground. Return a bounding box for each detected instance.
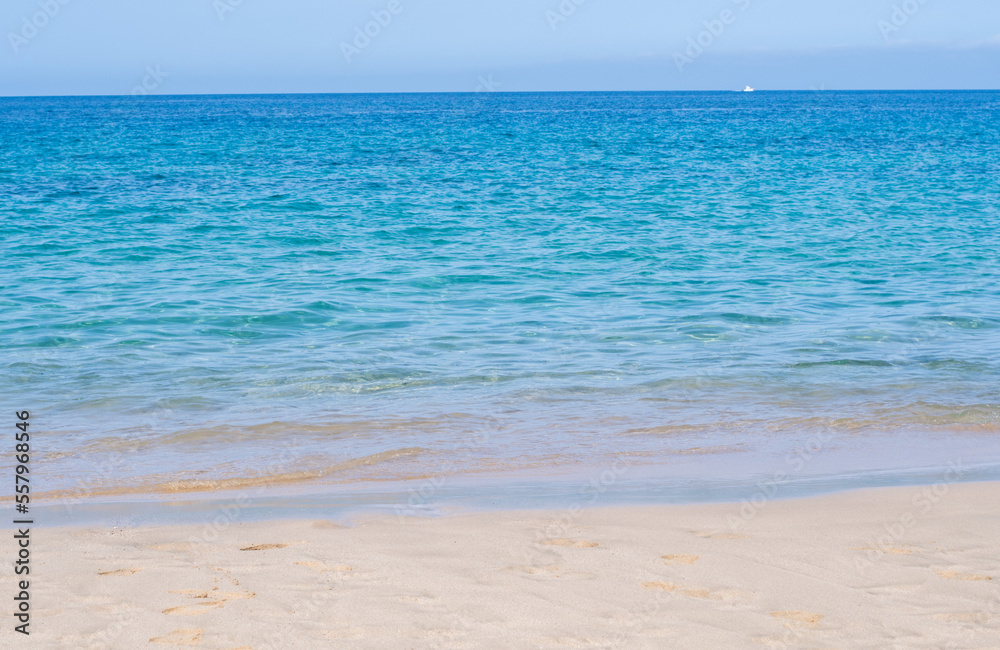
[13,483,1000,650]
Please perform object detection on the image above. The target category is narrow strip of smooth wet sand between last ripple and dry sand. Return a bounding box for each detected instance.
[21,460,1000,528]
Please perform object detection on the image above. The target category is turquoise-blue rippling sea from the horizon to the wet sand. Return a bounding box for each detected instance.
[0,92,1000,506]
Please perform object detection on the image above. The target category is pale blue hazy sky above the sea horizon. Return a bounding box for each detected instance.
[0,0,1000,96]
